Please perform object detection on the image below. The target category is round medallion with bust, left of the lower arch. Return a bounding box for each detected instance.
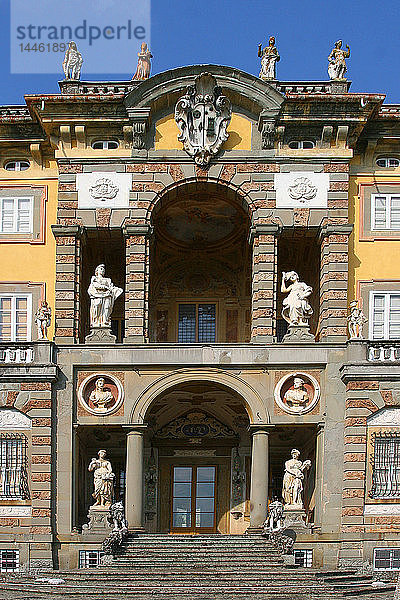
[78,373,124,416]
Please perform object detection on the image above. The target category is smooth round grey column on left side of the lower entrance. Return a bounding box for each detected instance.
[125,425,146,530]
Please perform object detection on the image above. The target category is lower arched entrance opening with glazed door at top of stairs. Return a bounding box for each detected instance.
[144,381,251,533]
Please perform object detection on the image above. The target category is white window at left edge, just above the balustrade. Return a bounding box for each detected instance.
[0,294,32,342]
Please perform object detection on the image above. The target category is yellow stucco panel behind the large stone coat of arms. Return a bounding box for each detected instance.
[155,113,251,150]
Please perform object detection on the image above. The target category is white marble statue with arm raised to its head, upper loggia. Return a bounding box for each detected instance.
[281,271,313,325]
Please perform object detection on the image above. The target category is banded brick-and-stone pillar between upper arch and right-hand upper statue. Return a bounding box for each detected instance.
[249,224,280,343]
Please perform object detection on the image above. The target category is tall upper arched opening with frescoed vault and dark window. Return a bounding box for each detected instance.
[150,182,251,343]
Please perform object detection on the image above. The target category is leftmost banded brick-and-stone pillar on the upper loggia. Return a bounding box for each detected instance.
[51,225,84,344]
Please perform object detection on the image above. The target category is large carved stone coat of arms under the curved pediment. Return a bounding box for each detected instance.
[175,73,232,167]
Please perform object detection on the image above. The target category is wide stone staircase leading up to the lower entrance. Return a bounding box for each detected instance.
[0,534,394,600]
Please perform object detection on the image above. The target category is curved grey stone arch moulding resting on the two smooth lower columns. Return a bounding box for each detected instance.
[129,369,270,425]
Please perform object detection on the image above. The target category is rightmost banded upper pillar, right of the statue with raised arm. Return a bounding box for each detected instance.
[319,225,353,343]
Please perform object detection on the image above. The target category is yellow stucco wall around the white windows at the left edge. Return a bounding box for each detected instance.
[0,163,57,340]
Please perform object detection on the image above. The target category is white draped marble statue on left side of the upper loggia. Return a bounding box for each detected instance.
[88,265,123,328]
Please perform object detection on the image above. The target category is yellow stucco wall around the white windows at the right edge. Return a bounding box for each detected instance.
[349,173,400,299]
